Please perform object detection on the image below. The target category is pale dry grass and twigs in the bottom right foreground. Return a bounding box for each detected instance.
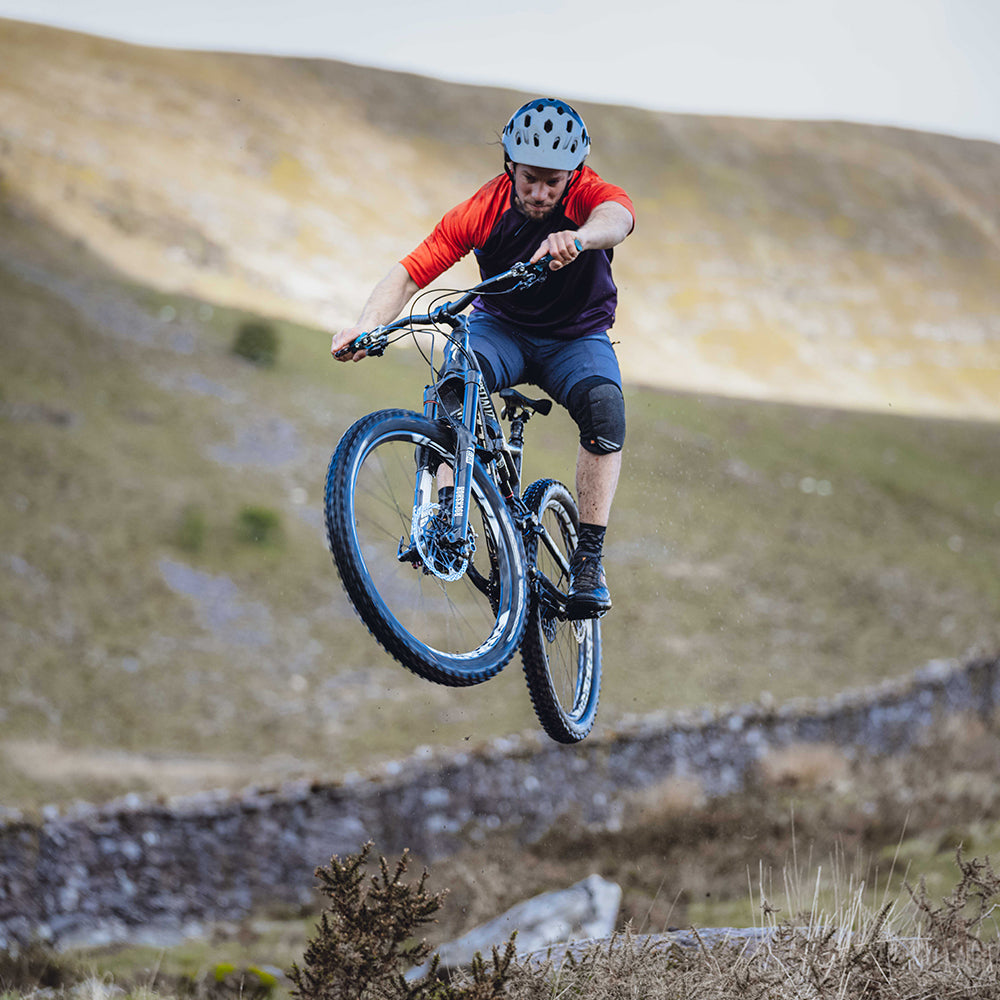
[506,853,1000,1000]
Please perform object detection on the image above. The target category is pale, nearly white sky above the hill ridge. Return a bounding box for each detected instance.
[0,0,1000,142]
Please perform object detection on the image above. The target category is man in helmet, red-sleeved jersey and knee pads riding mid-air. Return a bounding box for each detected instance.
[331,98,634,619]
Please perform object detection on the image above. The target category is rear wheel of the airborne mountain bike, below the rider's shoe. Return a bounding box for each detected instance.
[521,479,601,743]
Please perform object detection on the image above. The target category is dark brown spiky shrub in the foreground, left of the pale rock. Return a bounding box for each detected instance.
[288,842,514,1000]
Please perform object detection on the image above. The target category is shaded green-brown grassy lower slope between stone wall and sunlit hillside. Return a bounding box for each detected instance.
[0,199,1000,805]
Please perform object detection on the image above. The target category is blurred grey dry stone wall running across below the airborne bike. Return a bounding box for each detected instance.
[0,658,1000,949]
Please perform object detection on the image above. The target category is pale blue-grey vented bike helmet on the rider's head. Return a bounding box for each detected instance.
[503,97,590,170]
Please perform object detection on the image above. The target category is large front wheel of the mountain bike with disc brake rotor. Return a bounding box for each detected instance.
[326,410,528,687]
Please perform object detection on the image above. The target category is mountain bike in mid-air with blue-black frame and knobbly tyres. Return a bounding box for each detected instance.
[325,257,601,743]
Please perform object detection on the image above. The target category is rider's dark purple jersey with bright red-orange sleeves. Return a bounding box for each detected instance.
[402,167,635,340]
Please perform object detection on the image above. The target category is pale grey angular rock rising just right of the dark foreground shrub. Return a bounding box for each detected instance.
[407,875,622,980]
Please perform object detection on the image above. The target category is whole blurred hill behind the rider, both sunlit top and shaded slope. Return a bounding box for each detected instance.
[0,20,1000,805]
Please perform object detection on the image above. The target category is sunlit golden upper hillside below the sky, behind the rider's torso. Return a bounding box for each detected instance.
[0,21,1000,420]
